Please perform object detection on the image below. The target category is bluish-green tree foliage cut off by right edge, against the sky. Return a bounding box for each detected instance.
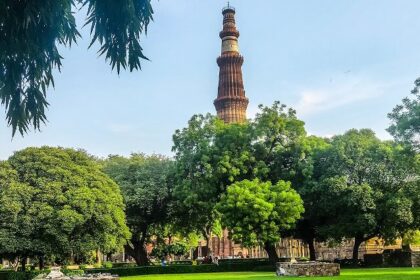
[388,78,420,151]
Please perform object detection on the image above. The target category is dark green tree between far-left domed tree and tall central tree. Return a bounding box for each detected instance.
[104,154,173,265]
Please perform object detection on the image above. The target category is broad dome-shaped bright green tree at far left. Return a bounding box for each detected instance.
[0,147,130,267]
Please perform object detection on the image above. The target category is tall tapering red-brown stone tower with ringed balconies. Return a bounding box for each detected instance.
[214,4,249,123]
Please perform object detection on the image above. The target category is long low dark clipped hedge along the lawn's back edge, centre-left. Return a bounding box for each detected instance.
[86,262,275,277]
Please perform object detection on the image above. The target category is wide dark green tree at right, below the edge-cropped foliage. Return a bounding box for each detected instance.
[312,129,419,259]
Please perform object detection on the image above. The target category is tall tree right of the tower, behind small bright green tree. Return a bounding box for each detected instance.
[252,102,328,260]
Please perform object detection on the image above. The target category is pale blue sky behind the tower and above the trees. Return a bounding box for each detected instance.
[0,0,420,159]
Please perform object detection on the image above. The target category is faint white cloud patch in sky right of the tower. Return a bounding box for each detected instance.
[293,75,391,116]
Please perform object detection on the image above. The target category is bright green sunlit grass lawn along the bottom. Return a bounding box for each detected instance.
[122,268,420,280]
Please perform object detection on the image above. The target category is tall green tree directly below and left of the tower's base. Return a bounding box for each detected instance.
[173,115,254,254]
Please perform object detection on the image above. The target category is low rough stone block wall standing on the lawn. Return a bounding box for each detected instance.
[277,262,340,276]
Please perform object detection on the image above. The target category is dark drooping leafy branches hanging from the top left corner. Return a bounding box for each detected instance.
[0,0,153,134]
